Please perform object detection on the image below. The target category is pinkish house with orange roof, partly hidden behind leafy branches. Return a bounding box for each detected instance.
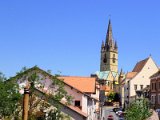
[14,67,99,120]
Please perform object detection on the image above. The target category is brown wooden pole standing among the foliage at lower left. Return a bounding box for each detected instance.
[22,87,29,120]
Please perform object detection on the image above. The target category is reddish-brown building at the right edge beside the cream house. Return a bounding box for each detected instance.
[150,71,160,109]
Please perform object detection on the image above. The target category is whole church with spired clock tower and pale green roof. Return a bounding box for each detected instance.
[96,20,119,94]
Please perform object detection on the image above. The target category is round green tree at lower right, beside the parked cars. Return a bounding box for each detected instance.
[125,99,151,120]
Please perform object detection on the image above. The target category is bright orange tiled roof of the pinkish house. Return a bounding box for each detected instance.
[59,76,96,93]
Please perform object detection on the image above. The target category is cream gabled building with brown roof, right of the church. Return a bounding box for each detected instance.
[124,56,158,106]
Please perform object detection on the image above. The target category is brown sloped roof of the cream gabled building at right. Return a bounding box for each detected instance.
[132,57,149,72]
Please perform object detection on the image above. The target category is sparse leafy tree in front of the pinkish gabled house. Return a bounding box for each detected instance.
[13,66,72,120]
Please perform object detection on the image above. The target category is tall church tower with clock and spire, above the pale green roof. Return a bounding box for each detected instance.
[100,20,118,72]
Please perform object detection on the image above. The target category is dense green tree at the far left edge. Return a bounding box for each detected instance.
[0,73,21,119]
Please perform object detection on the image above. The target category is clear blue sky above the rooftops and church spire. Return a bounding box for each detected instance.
[0,0,160,77]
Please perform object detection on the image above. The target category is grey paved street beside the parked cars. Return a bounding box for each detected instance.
[102,106,119,120]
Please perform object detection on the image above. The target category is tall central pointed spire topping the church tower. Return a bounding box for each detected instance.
[106,19,113,47]
